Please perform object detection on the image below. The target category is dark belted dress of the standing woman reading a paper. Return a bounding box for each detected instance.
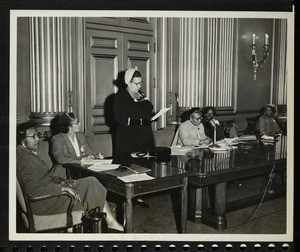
[113,89,154,157]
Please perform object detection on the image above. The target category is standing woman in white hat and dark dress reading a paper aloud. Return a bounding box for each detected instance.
[113,68,154,158]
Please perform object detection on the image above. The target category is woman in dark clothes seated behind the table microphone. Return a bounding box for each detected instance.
[201,107,224,141]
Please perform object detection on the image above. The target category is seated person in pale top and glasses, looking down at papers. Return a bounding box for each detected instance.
[176,108,211,146]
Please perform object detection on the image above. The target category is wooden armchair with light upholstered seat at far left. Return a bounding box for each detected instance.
[17,172,84,232]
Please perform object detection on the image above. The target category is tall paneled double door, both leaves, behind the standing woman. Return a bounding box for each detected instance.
[85,23,155,156]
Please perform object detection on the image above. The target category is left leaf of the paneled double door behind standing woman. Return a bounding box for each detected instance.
[85,29,123,135]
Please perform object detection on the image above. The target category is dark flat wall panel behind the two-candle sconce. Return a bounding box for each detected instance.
[237,19,273,112]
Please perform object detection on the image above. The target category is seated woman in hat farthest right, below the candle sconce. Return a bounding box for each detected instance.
[256,104,282,137]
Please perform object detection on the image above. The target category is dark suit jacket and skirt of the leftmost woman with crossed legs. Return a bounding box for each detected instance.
[17,146,106,215]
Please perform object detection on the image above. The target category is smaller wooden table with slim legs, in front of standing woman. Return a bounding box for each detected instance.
[63,159,188,233]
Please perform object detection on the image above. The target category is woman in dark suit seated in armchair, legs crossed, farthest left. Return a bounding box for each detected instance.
[17,122,124,231]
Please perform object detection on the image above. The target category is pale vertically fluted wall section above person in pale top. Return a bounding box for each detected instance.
[178,18,237,109]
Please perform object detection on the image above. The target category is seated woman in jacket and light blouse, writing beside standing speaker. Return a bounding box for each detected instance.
[51,113,104,178]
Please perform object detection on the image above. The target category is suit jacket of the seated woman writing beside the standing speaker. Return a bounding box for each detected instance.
[51,132,97,178]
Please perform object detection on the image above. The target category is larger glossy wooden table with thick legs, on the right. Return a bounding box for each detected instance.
[170,136,287,230]
